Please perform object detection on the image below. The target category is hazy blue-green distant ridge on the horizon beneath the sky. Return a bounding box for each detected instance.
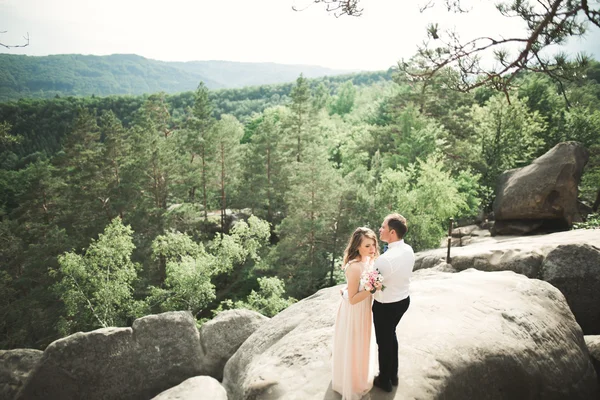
[0,54,353,101]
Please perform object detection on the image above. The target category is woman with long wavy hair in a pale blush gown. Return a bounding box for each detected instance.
[331,228,379,400]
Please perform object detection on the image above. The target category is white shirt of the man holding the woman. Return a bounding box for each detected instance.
[374,240,415,303]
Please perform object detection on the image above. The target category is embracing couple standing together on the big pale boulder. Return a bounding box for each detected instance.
[331,214,415,400]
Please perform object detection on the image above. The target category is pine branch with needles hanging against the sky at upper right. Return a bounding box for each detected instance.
[399,0,587,95]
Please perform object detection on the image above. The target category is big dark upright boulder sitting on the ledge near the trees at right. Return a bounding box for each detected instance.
[493,142,589,235]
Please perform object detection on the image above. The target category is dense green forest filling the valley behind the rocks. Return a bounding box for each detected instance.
[0,61,600,349]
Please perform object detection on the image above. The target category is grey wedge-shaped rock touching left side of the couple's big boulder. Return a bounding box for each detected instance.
[200,310,269,381]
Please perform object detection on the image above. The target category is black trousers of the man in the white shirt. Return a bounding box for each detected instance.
[373,297,410,380]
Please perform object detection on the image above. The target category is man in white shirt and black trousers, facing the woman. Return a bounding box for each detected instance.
[373,214,415,392]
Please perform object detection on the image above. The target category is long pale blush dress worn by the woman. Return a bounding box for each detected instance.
[331,261,377,400]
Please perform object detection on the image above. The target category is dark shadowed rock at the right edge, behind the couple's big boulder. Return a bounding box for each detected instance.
[540,244,600,335]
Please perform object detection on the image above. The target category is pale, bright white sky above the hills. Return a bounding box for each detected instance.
[0,0,600,70]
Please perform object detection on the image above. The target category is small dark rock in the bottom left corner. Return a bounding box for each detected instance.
[0,349,44,399]
